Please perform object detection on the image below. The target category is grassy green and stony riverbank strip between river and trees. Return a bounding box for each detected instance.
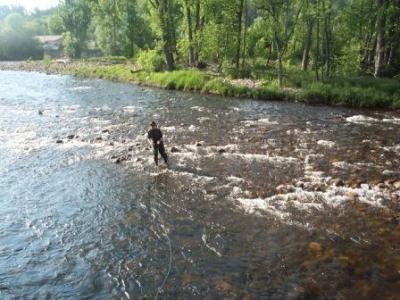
[0,61,400,109]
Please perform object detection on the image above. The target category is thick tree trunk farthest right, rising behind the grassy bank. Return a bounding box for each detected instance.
[374,0,387,77]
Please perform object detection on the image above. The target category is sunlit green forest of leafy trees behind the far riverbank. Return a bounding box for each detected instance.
[0,0,400,106]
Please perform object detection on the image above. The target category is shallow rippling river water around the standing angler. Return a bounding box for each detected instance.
[0,71,400,299]
